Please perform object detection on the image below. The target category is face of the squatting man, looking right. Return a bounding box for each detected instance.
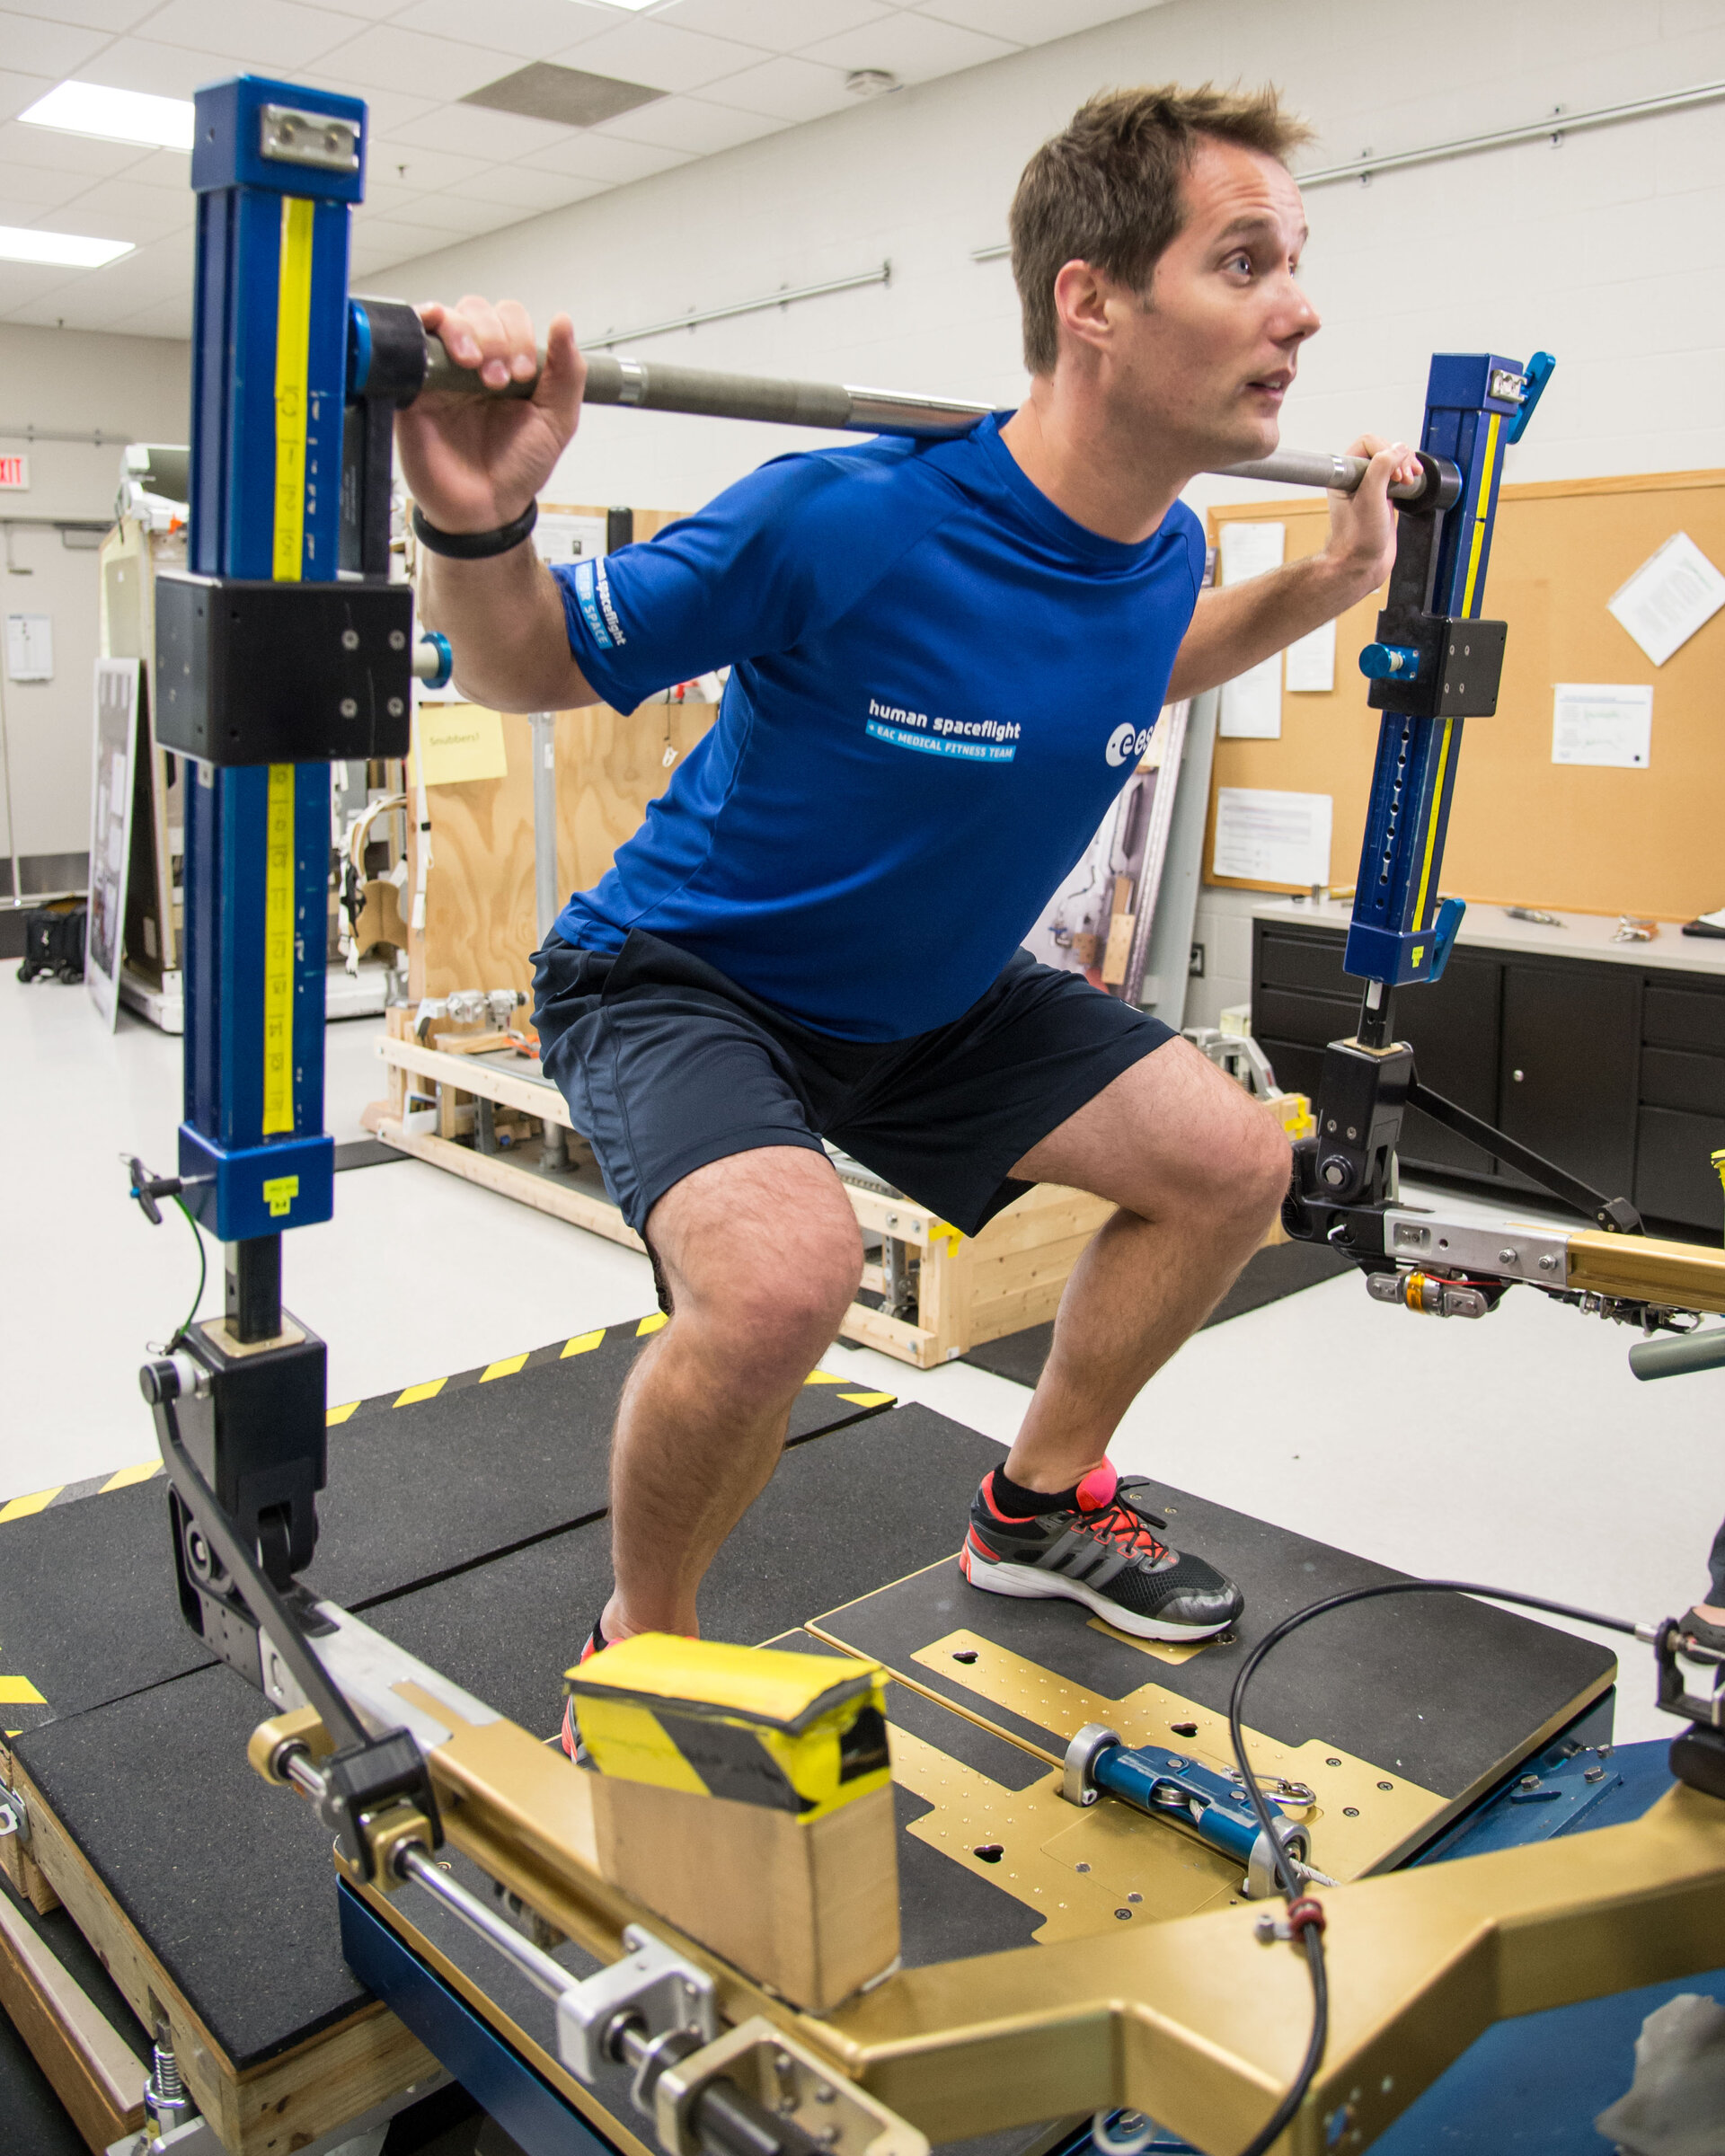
[1110,138,1317,470]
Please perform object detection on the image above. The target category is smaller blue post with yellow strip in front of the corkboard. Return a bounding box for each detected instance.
[1343,351,1526,987]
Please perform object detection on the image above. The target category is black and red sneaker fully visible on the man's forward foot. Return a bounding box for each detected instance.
[958,1460,1246,1640]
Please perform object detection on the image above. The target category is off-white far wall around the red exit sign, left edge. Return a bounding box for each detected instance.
[0,323,190,875]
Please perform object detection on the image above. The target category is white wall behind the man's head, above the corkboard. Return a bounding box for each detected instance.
[376,0,1725,1022]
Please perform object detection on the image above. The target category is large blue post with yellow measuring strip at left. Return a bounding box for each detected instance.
[179,75,365,1249]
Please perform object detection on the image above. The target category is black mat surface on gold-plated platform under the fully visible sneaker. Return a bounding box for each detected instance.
[819,1466,1617,1798]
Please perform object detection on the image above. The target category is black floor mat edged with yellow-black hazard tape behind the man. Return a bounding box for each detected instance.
[0,1320,890,1731]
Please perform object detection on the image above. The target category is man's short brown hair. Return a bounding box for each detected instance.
[1012,82,1314,376]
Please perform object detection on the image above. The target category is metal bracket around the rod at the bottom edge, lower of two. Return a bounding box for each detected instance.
[653,2014,929,2156]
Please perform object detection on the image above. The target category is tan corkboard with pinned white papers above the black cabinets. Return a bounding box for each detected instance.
[1203,473,1725,921]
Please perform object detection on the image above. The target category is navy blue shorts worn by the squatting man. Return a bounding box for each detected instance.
[533,929,1173,1235]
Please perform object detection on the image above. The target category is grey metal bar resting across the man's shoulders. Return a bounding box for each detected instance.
[422,336,1423,500]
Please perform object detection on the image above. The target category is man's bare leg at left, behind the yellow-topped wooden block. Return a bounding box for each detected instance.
[602,1144,862,1640]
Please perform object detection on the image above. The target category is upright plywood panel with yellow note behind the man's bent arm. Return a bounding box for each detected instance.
[408,508,716,996]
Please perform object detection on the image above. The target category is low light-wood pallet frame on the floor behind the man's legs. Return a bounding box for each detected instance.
[376,1012,1112,1369]
